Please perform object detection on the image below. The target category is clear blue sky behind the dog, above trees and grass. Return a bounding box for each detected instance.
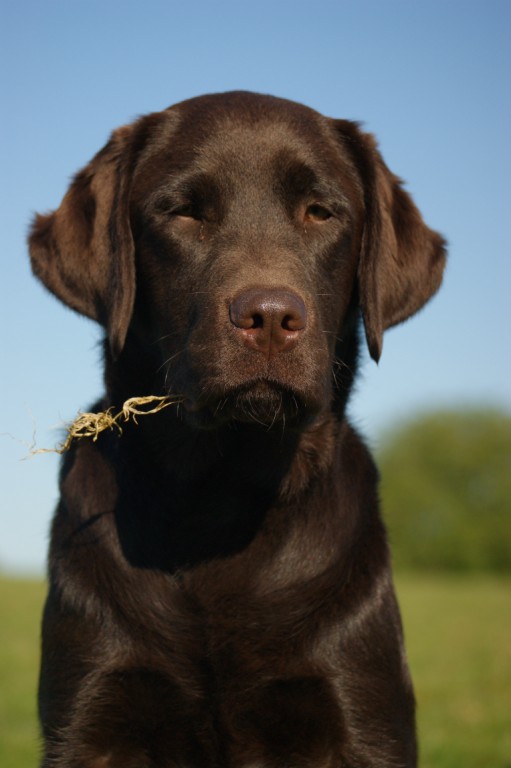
[0,0,511,571]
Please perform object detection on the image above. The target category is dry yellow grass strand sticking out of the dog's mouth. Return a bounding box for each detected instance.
[30,395,182,454]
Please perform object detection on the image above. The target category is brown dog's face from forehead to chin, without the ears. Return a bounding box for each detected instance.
[131,95,364,424]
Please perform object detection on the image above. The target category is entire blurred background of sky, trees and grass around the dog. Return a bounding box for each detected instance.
[0,0,511,768]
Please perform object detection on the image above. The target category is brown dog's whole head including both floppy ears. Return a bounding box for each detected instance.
[30,93,445,425]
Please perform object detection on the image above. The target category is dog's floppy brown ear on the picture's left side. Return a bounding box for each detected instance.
[29,126,135,356]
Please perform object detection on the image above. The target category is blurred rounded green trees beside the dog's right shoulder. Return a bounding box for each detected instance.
[378,410,511,573]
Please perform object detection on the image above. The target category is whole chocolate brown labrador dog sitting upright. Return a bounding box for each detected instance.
[30,92,445,768]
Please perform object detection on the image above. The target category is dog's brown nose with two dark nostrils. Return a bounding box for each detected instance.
[229,288,307,357]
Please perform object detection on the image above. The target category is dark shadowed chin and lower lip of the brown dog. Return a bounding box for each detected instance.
[184,380,317,430]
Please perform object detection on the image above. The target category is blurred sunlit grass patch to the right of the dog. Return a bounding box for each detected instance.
[398,575,511,768]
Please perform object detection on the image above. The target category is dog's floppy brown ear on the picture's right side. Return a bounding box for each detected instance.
[336,120,446,361]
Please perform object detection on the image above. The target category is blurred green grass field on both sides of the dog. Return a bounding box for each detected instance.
[0,575,511,768]
